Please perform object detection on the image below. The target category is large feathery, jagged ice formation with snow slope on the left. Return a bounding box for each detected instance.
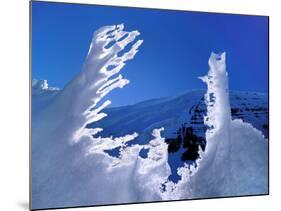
[32,25,170,209]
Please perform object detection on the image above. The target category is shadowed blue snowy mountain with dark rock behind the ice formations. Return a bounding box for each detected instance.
[87,90,268,181]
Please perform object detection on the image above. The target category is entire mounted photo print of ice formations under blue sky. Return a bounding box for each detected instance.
[30,1,269,210]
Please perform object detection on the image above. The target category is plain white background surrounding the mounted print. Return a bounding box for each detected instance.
[0,0,281,211]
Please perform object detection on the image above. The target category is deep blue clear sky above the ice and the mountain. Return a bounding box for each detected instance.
[32,2,268,106]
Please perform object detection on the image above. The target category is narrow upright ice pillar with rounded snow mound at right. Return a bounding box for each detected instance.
[160,53,268,199]
